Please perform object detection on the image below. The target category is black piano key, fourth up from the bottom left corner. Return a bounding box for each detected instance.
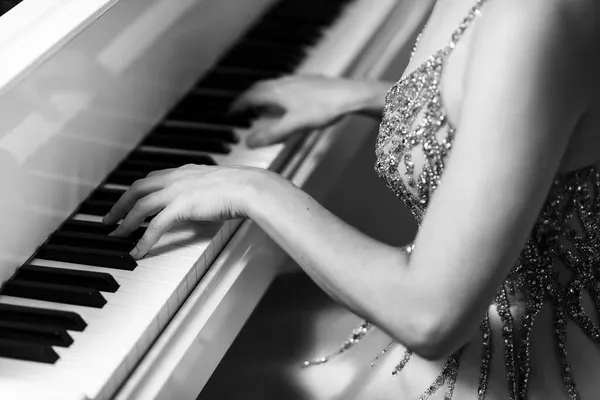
[0,278,106,308]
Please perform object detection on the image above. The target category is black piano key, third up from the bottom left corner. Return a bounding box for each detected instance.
[0,304,87,332]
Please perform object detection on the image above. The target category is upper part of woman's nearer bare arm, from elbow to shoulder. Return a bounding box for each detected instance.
[407,0,585,356]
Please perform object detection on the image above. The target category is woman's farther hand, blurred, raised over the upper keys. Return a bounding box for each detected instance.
[232,75,370,147]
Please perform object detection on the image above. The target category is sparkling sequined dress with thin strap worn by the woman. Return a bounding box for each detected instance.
[305,0,600,400]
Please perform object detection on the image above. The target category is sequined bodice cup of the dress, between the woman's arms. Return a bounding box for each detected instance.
[375,46,455,223]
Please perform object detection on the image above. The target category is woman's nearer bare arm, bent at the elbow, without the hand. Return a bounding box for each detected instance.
[238,1,585,358]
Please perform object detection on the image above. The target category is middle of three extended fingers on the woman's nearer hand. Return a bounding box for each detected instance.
[109,187,175,237]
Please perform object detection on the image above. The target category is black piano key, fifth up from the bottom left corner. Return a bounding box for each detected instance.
[15,265,119,293]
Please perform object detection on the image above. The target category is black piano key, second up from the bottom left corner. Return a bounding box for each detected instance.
[0,321,73,347]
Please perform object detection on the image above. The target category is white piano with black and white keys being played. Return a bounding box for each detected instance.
[0,0,424,400]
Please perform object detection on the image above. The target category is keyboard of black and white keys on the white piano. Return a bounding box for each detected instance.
[0,0,400,399]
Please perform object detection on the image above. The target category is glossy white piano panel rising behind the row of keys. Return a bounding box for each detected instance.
[0,0,272,282]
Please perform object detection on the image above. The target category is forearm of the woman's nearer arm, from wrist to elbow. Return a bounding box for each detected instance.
[241,172,418,344]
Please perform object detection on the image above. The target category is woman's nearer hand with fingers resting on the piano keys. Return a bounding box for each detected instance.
[103,165,272,258]
